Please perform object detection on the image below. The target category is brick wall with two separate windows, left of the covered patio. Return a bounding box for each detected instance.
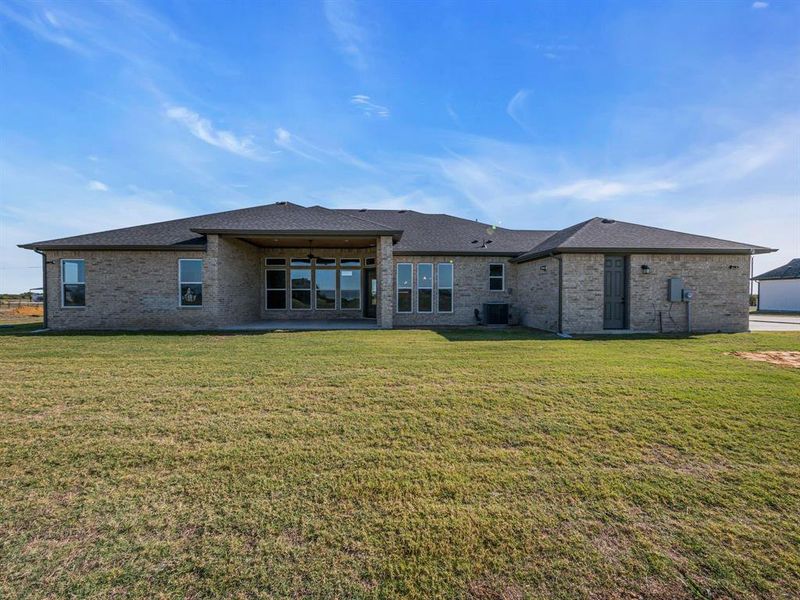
[47,245,211,329]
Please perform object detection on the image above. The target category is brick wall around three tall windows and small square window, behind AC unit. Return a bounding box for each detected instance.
[393,255,519,327]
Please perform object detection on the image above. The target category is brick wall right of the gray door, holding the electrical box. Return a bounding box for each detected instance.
[630,254,750,332]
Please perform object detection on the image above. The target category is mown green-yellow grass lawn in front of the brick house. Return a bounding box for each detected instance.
[0,325,800,599]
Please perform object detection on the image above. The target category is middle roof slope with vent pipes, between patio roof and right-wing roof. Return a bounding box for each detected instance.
[337,208,554,256]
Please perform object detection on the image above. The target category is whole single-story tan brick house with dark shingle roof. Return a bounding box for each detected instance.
[22,202,772,333]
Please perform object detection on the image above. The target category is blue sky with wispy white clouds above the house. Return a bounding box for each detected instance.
[0,0,800,292]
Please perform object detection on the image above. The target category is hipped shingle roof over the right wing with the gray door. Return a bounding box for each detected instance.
[514,217,774,262]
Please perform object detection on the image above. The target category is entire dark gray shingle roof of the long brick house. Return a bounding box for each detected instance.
[22,202,771,261]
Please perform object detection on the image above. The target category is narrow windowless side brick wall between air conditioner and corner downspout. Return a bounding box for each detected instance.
[515,256,559,331]
